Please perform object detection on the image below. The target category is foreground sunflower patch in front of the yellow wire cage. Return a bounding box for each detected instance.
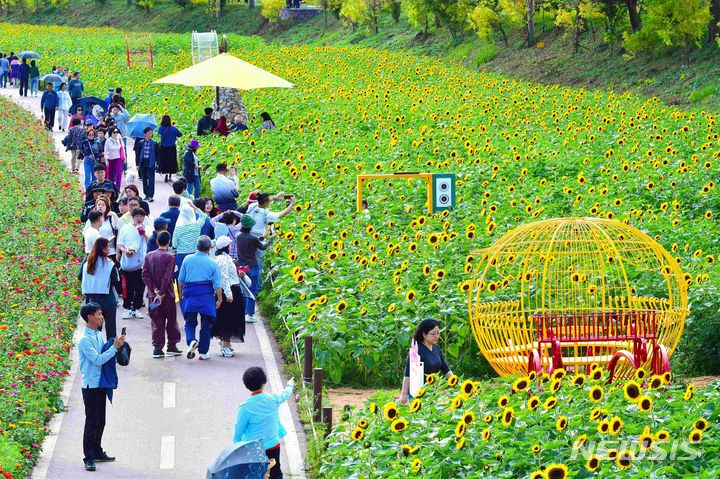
[320,372,720,479]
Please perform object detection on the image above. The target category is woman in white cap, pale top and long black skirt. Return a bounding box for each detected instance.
[211,236,245,358]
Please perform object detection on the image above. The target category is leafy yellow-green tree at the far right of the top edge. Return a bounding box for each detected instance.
[624,0,711,63]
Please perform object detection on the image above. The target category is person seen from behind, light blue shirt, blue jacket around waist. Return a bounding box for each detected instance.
[178,235,222,360]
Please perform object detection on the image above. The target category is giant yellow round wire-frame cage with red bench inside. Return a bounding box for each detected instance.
[468,218,688,380]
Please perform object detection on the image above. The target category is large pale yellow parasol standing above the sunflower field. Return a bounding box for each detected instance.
[153,53,293,90]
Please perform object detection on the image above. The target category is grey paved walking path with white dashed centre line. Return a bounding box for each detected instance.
[0,88,305,479]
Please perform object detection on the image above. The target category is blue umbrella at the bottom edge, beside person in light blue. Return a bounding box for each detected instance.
[205,441,270,479]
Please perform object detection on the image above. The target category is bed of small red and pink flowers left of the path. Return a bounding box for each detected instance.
[0,97,82,478]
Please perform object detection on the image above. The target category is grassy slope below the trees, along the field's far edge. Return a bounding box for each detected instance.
[6,0,720,112]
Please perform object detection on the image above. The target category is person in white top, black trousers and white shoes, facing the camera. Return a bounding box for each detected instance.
[117,208,149,319]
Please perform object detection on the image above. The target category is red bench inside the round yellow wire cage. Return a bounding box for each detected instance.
[528,310,670,381]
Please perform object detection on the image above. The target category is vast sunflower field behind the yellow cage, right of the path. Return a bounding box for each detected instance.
[0,24,720,392]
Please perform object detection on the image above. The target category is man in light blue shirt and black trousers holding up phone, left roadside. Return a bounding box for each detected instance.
[78,302,125,471]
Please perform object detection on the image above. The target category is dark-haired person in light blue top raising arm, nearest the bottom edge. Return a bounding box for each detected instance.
[233,367,295,479]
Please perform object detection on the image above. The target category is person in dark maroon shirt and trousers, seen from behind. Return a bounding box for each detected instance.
[142,231,182,358]
